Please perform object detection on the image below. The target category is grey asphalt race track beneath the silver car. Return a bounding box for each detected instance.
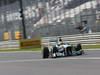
[0,49,100,75]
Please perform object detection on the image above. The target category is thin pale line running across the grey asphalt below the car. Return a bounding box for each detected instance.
[0,57,100,63]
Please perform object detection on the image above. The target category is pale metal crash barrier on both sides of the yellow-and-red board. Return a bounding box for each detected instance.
[0,33,100,49]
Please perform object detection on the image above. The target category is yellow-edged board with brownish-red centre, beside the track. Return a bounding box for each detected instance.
[20,38,41,49]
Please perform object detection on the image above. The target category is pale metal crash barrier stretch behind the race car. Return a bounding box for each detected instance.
[42,33,100,45]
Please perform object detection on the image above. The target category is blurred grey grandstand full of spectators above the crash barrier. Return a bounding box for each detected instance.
[0,0,100,41]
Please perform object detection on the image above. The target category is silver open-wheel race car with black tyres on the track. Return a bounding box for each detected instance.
[43,37,84,58]
